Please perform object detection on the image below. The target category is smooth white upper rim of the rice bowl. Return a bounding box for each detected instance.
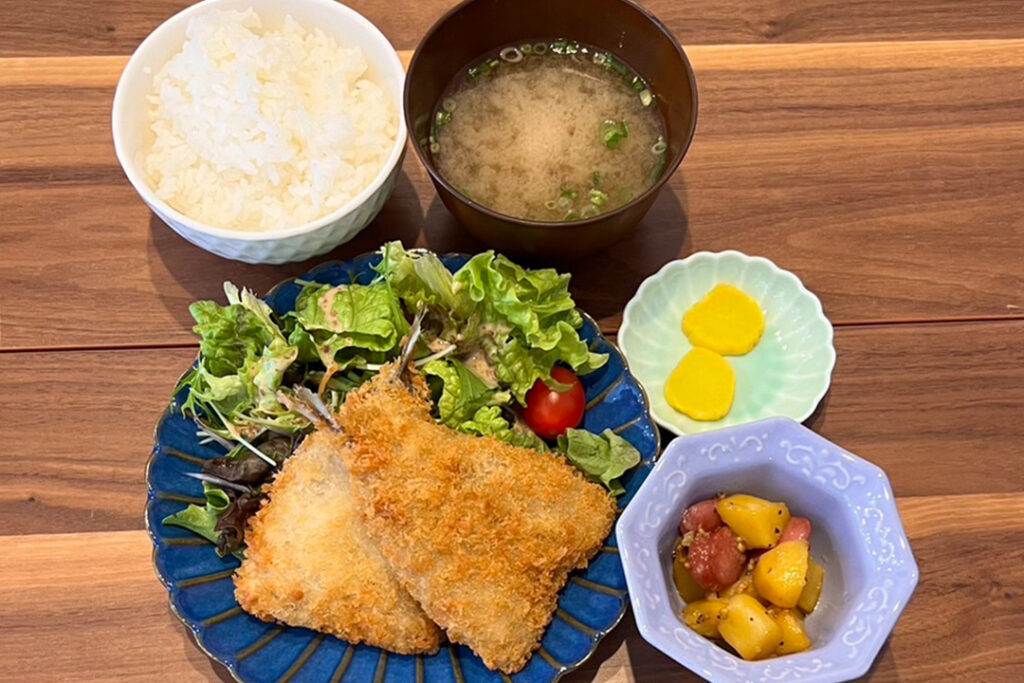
[111,0,408,242]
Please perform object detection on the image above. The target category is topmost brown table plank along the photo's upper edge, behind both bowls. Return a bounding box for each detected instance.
[0,0,1024,56]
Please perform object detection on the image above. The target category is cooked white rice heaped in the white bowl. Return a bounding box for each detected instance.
[145,8,397,231]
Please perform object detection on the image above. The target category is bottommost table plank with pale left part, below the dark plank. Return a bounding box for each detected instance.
[0,494,1024,683]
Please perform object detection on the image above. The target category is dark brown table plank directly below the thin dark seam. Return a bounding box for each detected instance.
[0,321,1024,540]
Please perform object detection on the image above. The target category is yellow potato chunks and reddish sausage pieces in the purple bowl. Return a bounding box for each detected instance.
[673,494,825,659]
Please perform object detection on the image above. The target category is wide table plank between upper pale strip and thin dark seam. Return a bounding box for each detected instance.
[0,40,1024,348]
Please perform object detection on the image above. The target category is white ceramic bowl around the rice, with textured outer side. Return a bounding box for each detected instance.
[112,0,407,263]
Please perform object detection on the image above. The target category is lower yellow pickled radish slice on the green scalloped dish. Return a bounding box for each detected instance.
[665,348,736,422]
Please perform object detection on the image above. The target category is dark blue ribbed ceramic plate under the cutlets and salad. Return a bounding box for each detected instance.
[145,254,659,683]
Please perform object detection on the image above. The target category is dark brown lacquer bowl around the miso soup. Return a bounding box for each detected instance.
[404,0,697,260]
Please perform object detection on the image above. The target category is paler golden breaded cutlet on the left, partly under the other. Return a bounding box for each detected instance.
[234,430,441,654]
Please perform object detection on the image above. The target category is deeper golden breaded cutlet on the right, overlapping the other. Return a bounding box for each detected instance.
[339,364,616,674]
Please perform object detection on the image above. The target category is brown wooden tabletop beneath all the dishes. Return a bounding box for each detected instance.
[0,0,1024,682]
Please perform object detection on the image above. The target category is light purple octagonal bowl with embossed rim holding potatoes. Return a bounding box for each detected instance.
[616,418,918,683]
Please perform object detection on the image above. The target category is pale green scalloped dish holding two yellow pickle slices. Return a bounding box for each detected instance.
[618,251,836,434]
